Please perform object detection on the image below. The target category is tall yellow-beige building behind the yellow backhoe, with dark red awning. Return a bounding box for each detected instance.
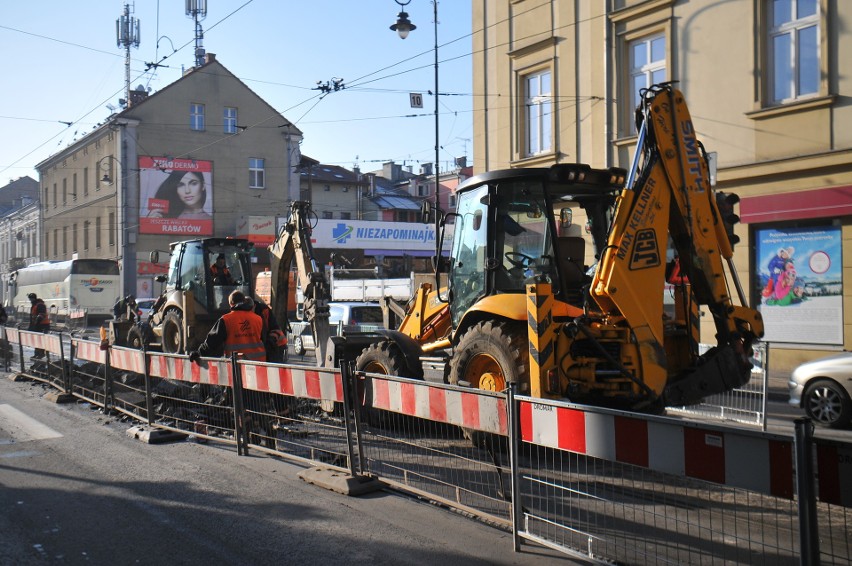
[473,0,852,371]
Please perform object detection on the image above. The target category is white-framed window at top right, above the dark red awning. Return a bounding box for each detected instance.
[768,0,820,103]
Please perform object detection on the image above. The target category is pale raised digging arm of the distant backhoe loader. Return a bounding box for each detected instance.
[269,201,331,364]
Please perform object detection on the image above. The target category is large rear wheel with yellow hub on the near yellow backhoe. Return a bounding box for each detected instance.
[448,320,530,393]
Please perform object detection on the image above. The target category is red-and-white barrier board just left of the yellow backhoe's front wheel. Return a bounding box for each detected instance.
[240,362,343,403]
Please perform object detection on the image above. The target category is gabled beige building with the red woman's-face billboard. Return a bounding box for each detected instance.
[36,53,302,296]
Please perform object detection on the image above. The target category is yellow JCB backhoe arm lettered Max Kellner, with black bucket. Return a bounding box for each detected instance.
[591,84,763,405]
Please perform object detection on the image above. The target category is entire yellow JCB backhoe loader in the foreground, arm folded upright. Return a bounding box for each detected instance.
[346,83,763,412]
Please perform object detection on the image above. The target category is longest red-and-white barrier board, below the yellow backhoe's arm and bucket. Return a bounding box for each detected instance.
[520,401,793,498]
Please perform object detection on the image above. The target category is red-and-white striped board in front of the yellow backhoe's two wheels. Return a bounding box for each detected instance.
[365,377,509,435]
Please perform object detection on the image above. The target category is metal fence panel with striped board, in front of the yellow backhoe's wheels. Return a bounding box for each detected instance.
[357,373,511,526]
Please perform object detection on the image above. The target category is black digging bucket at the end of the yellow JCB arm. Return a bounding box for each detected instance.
[664,345,752,407]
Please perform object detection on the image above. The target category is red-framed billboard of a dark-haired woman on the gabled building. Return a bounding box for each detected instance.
[139,156,213,236]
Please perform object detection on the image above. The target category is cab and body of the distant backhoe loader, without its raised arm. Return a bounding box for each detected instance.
[115,238,254,354]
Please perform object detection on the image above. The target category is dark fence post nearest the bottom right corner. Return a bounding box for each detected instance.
[794,417,819,565]
